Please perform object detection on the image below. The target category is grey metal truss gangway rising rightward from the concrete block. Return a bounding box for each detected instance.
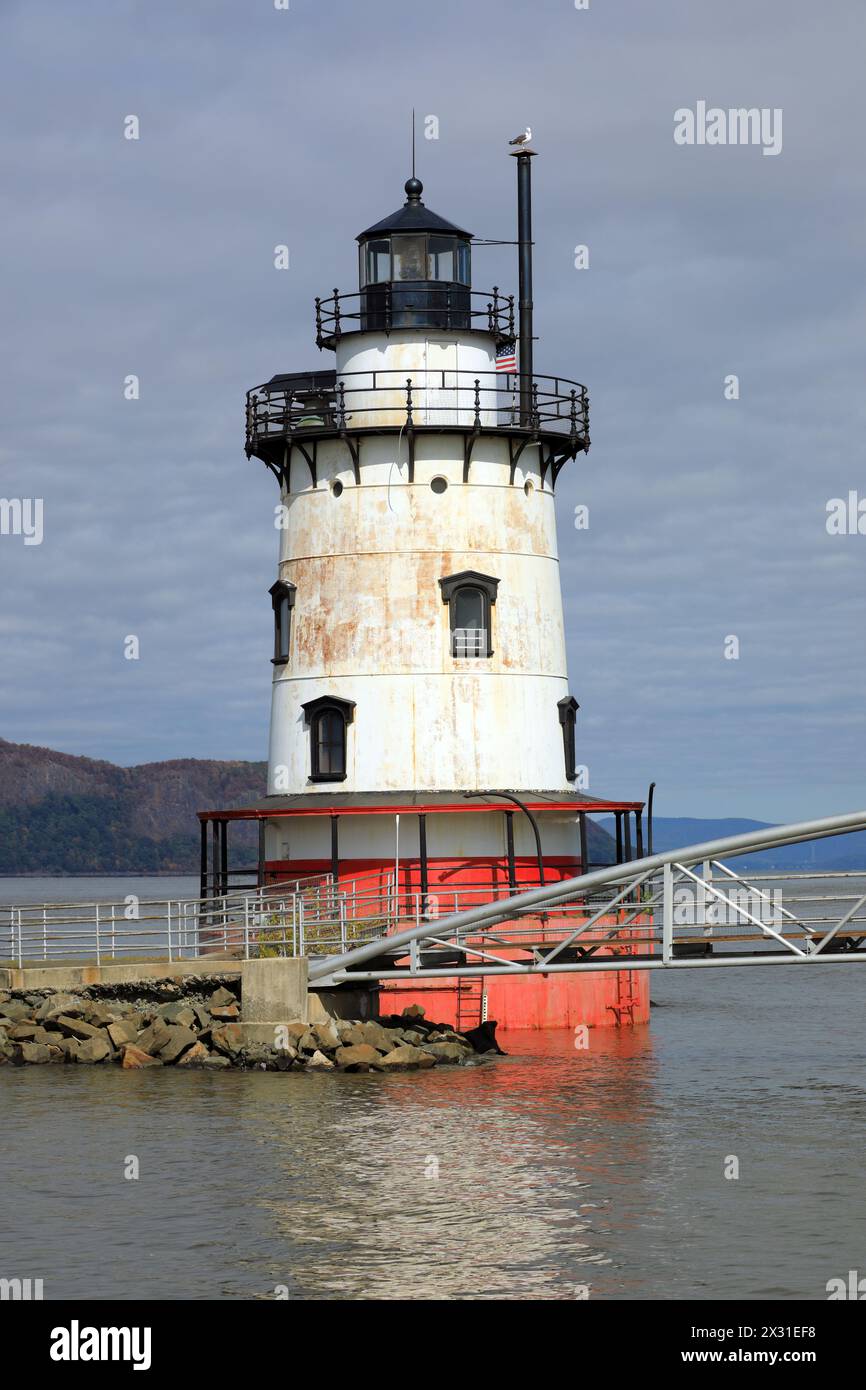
[304,812,866,988]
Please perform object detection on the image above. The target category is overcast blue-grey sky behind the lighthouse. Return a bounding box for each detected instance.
[0,0,866,820]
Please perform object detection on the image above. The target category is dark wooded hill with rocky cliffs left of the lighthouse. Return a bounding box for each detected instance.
[0,739,267,874]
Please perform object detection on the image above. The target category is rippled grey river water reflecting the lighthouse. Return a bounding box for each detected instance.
[0,880,866,1300]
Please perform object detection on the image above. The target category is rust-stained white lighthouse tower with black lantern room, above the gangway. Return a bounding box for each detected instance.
[200,149,642,1028]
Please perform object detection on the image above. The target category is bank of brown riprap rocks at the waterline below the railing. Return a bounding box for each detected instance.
[0,977,500,1073]
